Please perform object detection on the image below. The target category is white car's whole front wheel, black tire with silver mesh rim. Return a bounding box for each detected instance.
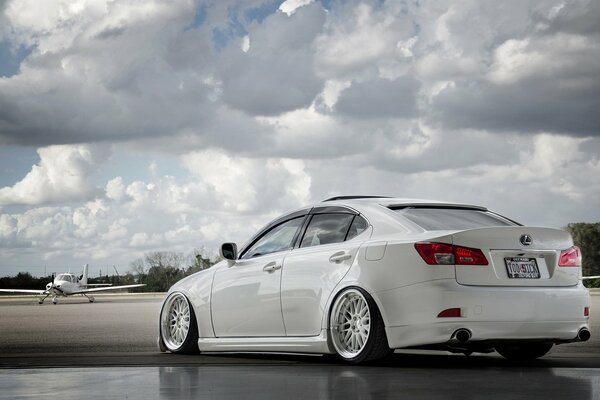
[159,292,199,354]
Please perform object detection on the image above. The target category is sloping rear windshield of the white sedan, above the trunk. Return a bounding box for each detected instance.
[394,207,518,231]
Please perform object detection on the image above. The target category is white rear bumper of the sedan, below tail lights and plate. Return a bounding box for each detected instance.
[373,280,590,348]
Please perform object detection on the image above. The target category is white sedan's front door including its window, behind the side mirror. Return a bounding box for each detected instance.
[211,216,305,337]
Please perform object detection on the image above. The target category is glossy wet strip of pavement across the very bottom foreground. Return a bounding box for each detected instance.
[0,361,600,400]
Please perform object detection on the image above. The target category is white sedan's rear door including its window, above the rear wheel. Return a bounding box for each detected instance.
[281,211,369,336]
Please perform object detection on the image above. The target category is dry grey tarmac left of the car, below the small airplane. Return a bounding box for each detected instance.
[0,294,164,355]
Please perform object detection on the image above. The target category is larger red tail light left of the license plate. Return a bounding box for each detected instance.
[415,242,488,265]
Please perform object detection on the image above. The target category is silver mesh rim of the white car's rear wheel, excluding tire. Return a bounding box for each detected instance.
[330,289,371,359]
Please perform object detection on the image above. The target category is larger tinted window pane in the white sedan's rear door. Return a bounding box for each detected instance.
[300,214,354,247]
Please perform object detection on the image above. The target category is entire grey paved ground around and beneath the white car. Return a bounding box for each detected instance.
[0,294,600,400]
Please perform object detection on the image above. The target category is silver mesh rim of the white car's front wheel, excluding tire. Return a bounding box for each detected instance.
[161,293,192,351]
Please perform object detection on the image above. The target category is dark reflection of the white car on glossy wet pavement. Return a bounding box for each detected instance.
[159,365,600,400]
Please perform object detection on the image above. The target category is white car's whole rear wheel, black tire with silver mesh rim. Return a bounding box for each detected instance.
[329,288,392,364]
